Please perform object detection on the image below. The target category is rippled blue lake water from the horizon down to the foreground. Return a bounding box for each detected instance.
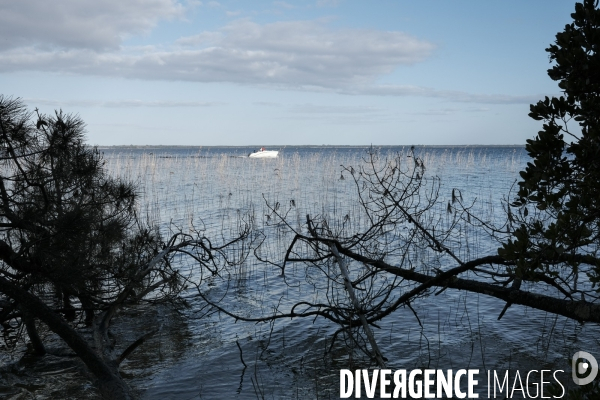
[1,146,600,399]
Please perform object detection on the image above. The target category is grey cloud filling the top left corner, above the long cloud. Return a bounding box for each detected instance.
[0,0,184,51]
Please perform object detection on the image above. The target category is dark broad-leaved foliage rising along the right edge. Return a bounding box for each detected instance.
[500,0,600,294]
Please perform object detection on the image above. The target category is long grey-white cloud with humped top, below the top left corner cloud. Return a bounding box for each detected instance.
[0,19,434,89]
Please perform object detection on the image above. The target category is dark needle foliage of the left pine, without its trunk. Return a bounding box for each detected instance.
[0,98,163,334]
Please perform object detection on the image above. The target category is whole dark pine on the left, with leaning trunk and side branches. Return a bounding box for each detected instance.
[0,96,248,399]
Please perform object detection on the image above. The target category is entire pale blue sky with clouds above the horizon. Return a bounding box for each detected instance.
[0,0,574,146]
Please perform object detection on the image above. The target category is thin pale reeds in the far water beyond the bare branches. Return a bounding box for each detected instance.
[107,148,526,259]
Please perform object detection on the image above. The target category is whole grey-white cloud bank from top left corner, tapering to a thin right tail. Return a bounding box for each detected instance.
[0,0,539,104]
